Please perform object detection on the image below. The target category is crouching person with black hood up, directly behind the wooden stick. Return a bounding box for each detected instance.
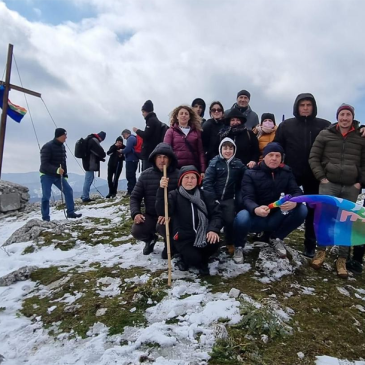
[130,143,179,259]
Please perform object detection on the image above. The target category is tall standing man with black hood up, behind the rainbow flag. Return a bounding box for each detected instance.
[274,93,331,257]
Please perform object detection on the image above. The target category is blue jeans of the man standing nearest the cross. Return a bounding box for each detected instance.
[41,175,75,221]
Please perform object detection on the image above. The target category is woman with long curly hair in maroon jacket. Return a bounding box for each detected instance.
[164,105,206,177]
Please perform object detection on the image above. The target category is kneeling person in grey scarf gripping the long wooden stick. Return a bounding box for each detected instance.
[156,165,223,275]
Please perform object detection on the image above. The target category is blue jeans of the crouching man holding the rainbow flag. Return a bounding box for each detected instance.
[233,204,308,247]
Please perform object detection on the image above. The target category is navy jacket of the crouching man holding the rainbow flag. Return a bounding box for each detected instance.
[241,161,303,214]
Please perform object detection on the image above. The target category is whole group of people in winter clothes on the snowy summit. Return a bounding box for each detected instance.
[41,90,365,277]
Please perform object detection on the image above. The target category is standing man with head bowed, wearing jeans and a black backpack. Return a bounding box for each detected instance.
[81,131,106,203]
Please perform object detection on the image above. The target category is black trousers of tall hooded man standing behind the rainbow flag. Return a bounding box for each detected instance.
[297,175,319,250]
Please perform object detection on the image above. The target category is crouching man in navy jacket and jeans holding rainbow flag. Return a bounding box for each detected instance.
[233,142,307,264]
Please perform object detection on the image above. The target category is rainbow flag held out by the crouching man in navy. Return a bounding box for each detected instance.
[290,195,365,246]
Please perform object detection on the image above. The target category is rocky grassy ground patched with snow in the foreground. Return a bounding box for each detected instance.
[0,196,365,365]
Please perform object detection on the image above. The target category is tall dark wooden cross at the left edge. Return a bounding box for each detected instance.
[0,44,42,178]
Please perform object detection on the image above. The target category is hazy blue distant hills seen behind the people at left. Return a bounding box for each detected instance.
[1,171,127,203]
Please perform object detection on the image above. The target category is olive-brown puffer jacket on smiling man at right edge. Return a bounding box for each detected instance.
[309,124,365,185]
